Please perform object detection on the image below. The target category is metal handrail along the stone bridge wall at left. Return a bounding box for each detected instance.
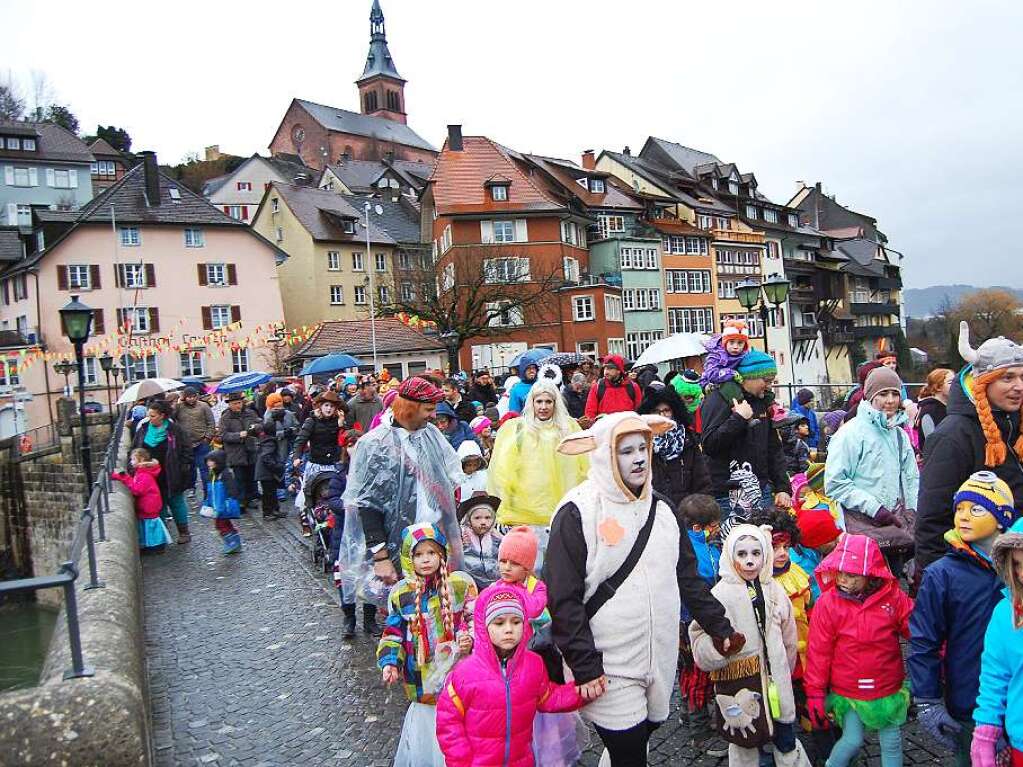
[0,407,128,679]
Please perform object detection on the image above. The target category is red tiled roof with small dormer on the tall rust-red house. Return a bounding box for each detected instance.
[431,136,565,215]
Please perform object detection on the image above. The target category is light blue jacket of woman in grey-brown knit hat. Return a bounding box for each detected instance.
[825,402,920,516]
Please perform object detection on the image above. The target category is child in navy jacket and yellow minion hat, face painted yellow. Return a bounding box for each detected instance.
[906,471,1017,767]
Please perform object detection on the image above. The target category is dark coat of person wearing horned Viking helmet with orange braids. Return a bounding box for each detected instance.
[916,377,1023,568]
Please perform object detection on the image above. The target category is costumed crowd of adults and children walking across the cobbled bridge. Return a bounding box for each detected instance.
[117,323,1023,767]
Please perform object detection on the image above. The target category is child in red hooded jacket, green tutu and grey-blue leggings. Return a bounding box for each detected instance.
[803,534,913,767]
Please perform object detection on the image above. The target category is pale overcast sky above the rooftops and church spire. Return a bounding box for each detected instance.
[7,0,1023,287]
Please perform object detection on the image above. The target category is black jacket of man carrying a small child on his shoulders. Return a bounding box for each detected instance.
[701,382,791,497]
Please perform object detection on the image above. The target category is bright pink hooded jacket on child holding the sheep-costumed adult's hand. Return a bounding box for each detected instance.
[437,582,584,767]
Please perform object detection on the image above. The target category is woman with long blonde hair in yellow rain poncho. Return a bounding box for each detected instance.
[487,378,589,572]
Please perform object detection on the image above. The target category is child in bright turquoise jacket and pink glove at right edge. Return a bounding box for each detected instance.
[970,522,1023,767]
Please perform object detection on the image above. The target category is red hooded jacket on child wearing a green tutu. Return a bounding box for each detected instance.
[803,535,913,701]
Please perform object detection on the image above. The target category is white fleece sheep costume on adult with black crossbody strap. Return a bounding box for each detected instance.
[547,412,681,730]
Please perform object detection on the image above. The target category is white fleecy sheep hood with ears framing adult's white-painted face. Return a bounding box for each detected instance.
[558,412,675,502]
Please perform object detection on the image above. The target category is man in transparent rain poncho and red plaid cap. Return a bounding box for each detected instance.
[339,377,465,603]
